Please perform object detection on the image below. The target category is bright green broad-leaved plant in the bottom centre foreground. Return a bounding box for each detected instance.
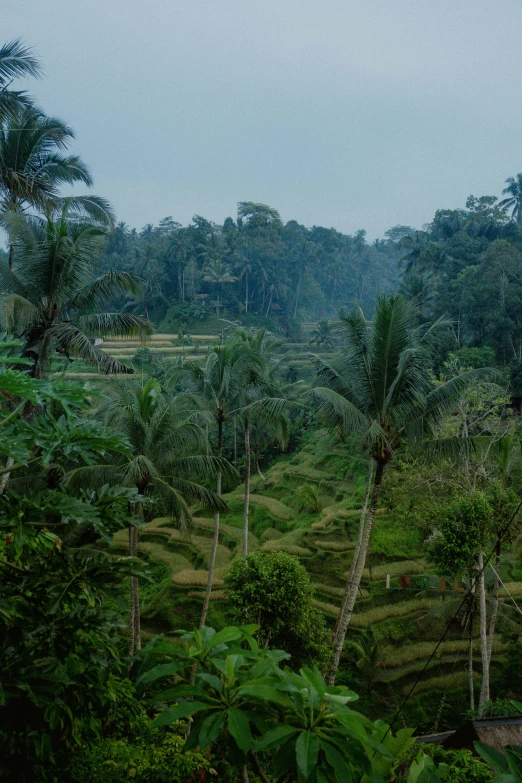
[148,626,413,783]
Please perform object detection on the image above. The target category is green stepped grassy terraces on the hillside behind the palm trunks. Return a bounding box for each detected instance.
[110,426,522,724]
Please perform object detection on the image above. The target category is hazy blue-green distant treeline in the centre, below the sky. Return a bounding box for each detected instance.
[97,202,400,327]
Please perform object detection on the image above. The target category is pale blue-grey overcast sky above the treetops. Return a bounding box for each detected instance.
[1,0,522,239]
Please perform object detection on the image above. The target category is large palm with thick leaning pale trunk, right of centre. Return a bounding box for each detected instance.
[311,294,488,682]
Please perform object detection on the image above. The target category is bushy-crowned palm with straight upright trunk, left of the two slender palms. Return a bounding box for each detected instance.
[91,378,227,656]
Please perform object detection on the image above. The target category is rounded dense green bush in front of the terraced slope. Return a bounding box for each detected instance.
[225,552,329,667]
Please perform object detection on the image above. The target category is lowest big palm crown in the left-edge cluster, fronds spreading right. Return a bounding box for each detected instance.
[0,203,152,377]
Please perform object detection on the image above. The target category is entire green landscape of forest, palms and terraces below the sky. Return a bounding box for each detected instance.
[5,40,522,783]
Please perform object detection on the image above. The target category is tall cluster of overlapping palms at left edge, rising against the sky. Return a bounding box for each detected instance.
[0,41,151,376]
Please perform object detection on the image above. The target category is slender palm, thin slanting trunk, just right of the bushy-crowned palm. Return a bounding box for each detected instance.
[171,339,260,628]
